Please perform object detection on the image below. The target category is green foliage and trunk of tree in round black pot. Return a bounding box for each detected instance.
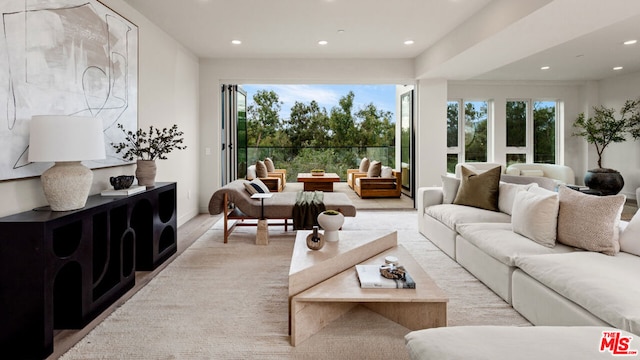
[573,98,640,168]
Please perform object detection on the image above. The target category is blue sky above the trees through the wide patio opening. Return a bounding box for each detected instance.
[242,84,396,121]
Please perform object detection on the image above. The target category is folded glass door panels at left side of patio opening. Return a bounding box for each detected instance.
[221,85,247,185]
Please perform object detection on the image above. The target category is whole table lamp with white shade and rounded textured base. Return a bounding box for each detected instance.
[29,115,105,211]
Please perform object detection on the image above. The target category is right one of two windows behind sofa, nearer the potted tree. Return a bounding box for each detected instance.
[506,100,557,166]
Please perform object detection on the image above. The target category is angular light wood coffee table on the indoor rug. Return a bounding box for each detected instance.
[289,231,448,346]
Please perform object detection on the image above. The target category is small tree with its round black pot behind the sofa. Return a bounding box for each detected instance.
[573,98,640,195]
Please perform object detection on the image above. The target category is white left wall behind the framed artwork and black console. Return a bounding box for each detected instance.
[0,0,199,225]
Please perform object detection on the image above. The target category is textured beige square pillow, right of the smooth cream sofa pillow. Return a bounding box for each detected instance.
[558,186,626,255]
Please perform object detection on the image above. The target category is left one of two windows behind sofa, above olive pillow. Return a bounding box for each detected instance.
[447,100,489,173]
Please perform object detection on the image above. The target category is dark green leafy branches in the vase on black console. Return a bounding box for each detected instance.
[111,124,187,161]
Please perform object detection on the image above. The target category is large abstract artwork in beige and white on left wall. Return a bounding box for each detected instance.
[0,0,138,180]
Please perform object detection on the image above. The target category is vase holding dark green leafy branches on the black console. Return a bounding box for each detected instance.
[111,124,187,186]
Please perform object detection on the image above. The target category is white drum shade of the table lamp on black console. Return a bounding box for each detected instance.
[29,115,106,162]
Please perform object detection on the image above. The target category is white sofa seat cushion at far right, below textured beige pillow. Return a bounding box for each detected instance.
[516,252,640,334]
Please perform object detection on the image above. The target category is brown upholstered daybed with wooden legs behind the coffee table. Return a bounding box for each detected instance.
[209,180,356,243]
